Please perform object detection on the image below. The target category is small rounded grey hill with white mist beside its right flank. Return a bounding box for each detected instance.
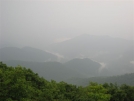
[65,58,101,77]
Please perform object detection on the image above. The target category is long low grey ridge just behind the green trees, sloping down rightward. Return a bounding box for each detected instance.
[3,60,85,81]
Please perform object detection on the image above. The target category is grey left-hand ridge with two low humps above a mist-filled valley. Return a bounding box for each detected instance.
[0,47,57,62]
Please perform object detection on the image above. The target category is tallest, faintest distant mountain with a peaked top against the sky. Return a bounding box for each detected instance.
[48,34,134,62]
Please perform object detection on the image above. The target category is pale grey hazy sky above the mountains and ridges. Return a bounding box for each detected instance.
[0,0,134,47]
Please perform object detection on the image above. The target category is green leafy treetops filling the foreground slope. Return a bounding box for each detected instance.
[0,62,134,101]
